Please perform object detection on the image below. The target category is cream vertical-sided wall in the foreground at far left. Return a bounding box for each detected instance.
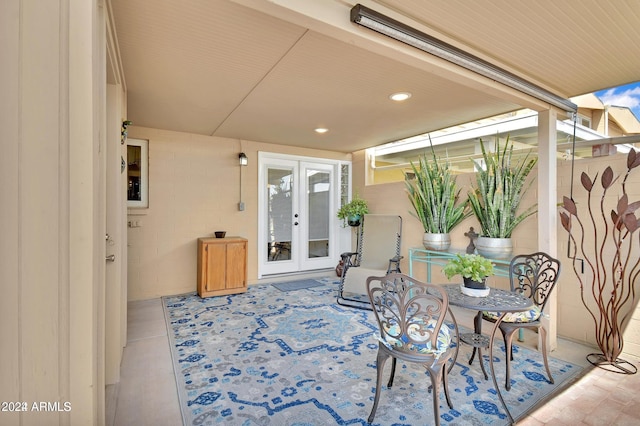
[0,0,104,426]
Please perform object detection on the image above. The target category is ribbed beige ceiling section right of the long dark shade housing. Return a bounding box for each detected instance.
[380,0,640,97]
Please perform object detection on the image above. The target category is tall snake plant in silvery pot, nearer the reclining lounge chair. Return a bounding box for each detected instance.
[405,146,471,250]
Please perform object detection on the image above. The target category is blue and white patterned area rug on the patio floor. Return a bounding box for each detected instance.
[163,278,581,426]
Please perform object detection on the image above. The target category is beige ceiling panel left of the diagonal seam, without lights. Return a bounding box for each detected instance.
[113,0,306,135]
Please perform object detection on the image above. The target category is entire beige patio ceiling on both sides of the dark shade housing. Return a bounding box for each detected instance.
[110,0,640,152]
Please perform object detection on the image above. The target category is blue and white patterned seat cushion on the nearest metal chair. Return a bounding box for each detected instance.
[378,320,451,358]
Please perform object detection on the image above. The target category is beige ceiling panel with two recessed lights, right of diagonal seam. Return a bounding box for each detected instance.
[216,32,518,151]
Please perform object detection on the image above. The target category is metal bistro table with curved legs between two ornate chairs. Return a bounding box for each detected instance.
[442,284,533,424]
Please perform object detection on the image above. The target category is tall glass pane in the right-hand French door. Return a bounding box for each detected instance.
[306,168,331,259]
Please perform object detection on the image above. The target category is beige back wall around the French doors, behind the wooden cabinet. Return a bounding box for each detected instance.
[128,126,351,300]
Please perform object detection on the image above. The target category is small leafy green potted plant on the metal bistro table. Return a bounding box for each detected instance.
[442,253,493,296]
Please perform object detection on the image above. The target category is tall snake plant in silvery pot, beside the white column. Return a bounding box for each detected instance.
[469,137,538,258]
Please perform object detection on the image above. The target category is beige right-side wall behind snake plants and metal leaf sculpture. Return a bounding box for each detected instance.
[353,152,640,355]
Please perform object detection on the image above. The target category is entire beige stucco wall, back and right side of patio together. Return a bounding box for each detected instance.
[122,126,640,354]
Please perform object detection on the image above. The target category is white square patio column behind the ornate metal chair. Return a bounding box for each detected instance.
[538,109,558,351]
